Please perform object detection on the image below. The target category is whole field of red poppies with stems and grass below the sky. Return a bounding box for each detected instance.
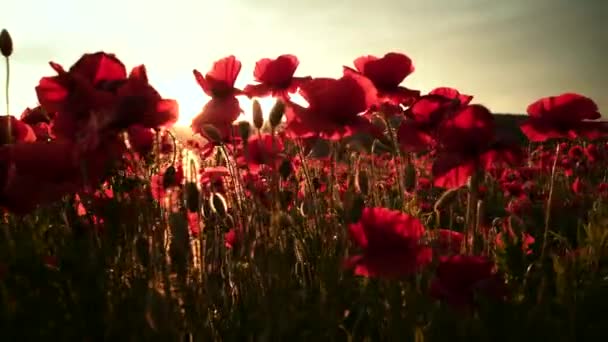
[0,31,608,342]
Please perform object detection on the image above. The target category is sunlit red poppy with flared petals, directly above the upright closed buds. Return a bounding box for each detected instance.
[243,55,311,99]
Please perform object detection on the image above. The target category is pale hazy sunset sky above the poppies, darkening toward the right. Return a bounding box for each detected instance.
[0,0,608,124]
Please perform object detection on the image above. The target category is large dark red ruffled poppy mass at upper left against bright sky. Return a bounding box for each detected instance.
[36,52,177,140]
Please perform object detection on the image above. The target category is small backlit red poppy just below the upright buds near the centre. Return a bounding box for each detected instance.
[237,134,284,173]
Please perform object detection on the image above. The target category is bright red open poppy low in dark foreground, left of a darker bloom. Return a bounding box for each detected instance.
[346,208,432,278]
